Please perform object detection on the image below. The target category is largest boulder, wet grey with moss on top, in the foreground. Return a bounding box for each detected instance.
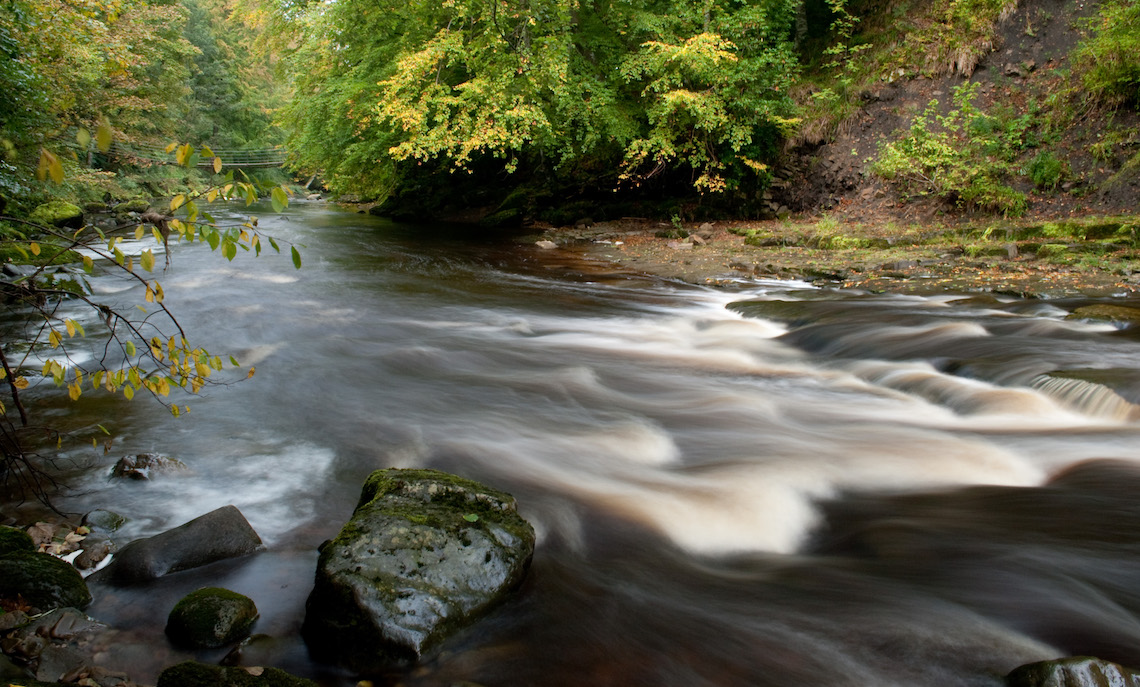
[302,469,535,672]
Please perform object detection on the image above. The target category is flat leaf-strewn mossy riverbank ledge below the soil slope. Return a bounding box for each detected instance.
[524,215,1140,297]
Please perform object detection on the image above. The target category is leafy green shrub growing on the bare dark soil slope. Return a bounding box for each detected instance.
[872,83,1026,216]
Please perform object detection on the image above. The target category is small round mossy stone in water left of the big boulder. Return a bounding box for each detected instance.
[166,587,258,648]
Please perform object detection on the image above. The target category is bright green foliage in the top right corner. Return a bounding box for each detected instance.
[1073,0,1140,107]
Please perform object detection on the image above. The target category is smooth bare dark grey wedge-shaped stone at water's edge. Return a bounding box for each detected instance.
[92,506,261,584]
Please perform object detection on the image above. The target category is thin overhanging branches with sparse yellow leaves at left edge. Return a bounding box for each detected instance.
[0,145,301,502]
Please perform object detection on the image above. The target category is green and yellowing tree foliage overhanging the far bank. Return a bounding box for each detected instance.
[278,0,797,203]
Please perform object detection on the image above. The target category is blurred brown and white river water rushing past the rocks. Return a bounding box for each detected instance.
[13,204,1140,687]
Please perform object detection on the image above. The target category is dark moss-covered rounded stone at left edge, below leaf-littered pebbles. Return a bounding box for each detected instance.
[0,551,91,612]
